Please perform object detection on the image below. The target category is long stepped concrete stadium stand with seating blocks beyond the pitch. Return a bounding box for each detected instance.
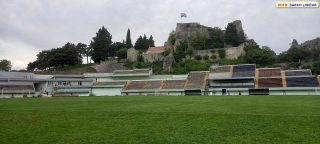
[0,64,320,98]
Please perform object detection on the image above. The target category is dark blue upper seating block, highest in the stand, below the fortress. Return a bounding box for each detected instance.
[232,64,256,77]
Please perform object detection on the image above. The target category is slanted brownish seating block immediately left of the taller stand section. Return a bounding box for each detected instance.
[185,72,207,89]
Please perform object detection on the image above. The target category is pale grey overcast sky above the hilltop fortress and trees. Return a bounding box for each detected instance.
[0,0,320,69]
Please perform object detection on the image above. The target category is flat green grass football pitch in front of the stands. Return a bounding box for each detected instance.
[0,96,320,144]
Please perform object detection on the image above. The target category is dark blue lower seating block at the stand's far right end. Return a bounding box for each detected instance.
[286,76,319,87]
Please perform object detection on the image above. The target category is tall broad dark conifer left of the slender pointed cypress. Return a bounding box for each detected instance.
[90,26,115,63]
